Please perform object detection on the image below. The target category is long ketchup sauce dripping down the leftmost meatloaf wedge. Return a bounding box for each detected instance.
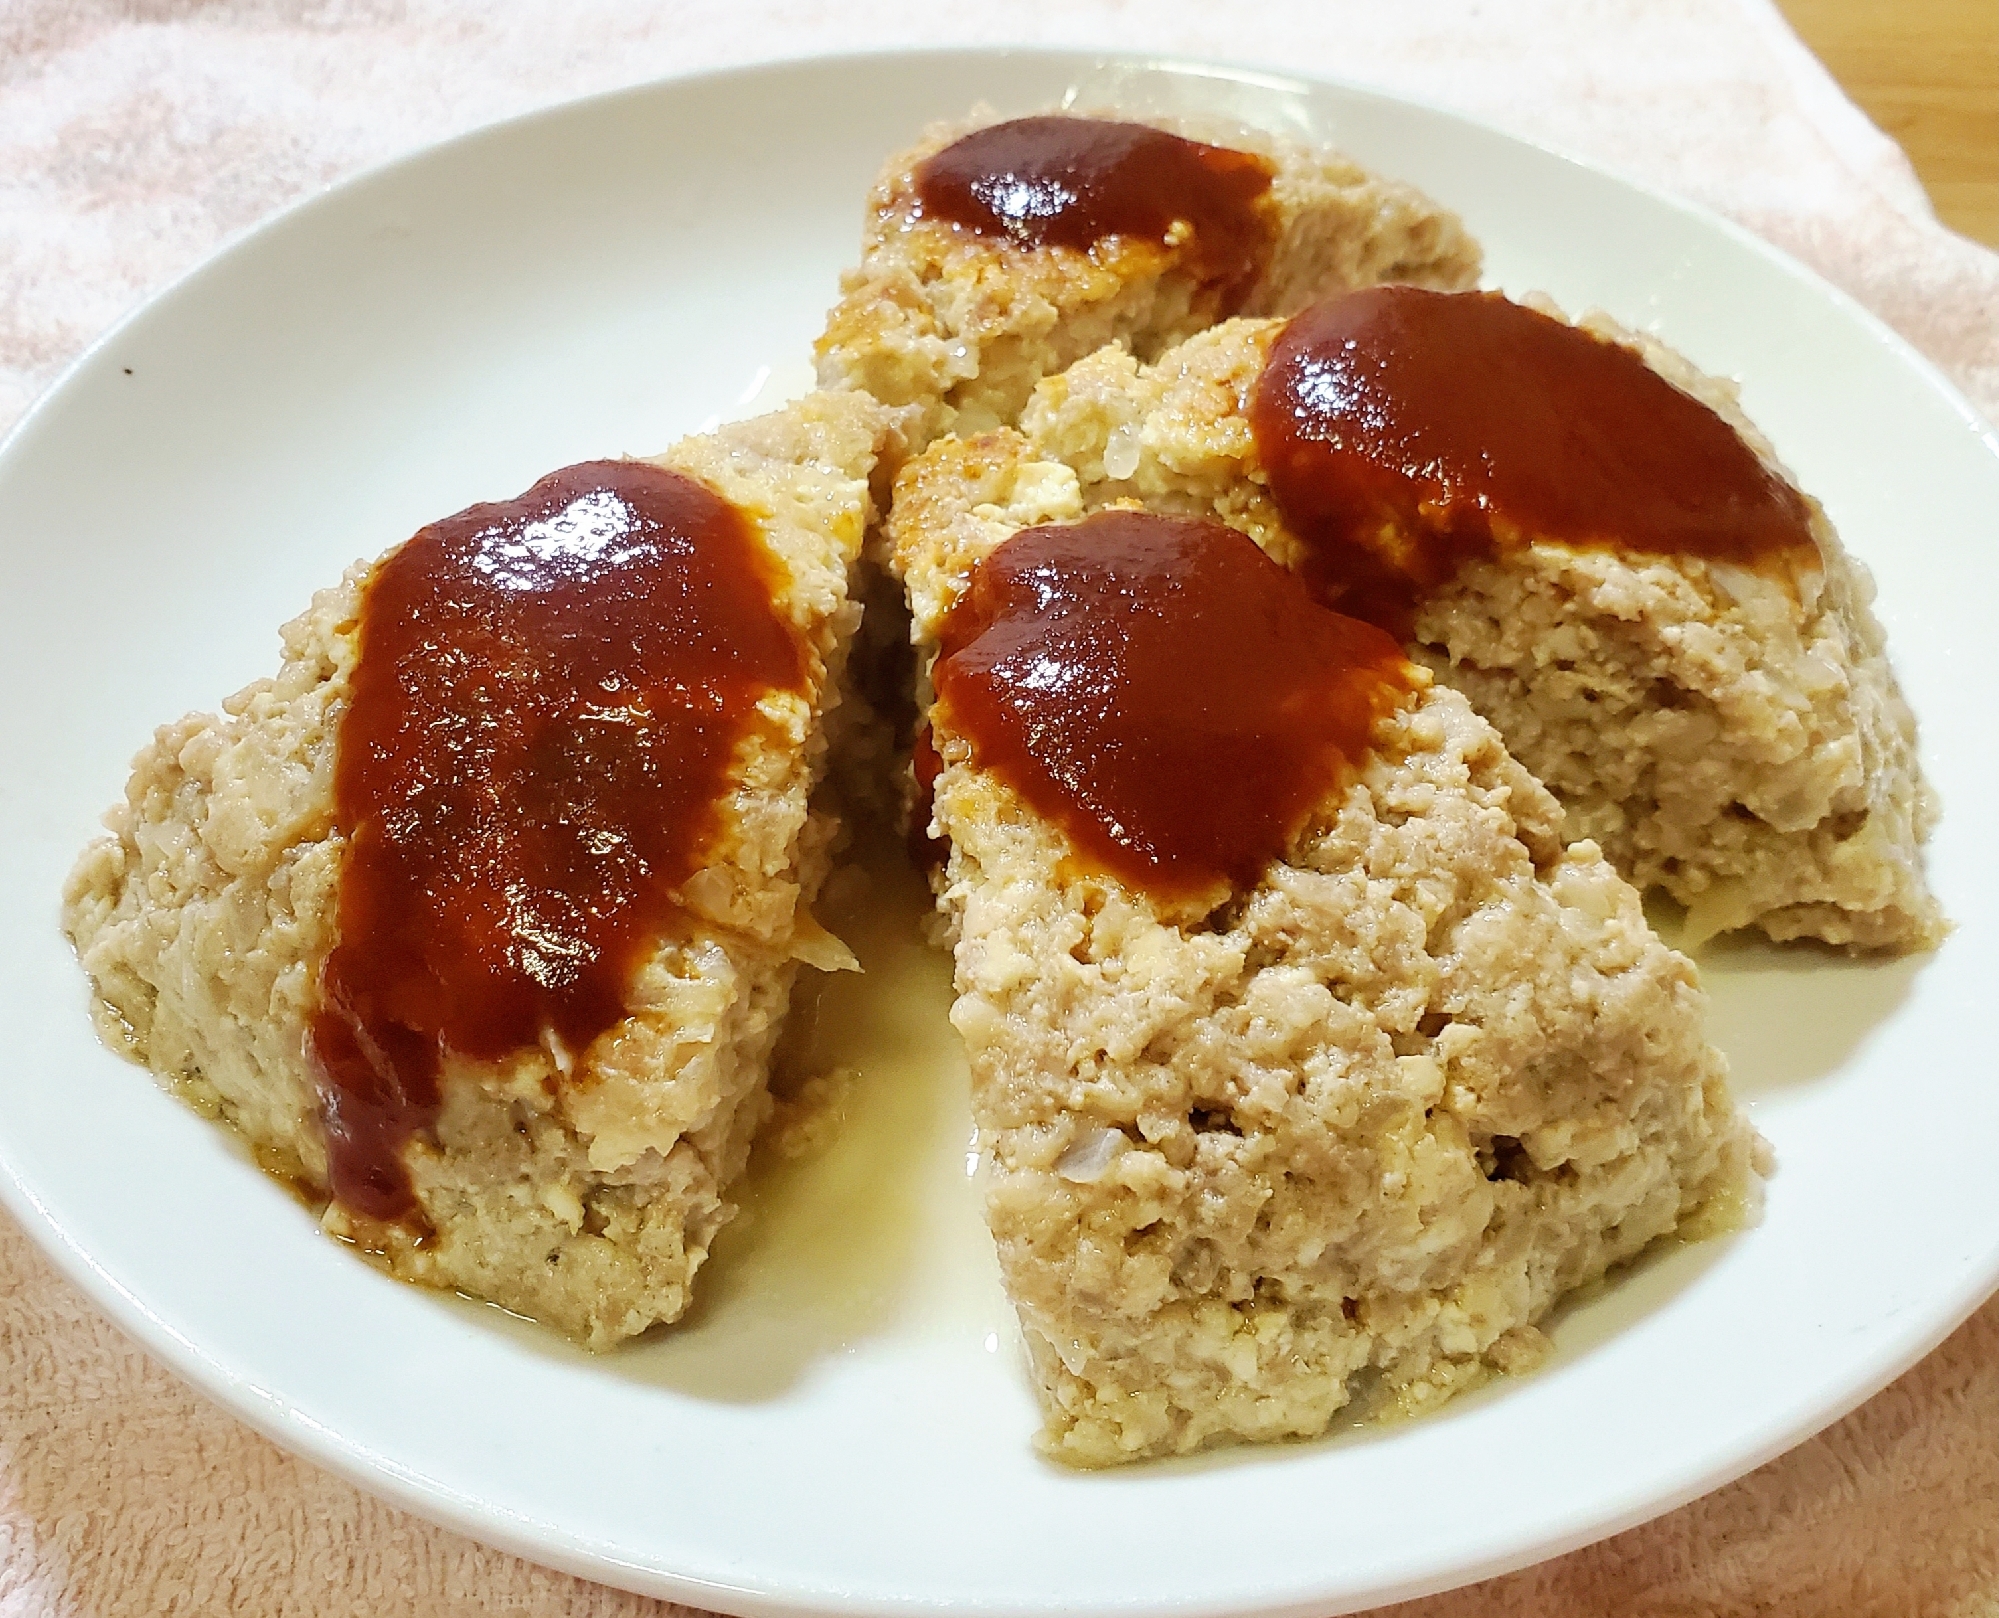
[310,462,808,1220]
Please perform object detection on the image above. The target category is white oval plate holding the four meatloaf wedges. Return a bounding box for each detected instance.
[0,52,1999,1614]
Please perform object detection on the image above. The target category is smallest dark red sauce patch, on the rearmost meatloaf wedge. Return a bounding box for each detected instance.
[916,116,1273,312]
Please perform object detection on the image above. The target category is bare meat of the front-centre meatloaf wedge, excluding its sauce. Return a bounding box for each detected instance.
[890,432,1755,1466]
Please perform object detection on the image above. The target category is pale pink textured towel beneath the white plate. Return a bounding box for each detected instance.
[0,0,1999,1618]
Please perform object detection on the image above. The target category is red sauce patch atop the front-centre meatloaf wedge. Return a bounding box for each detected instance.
[932,510,1421,906]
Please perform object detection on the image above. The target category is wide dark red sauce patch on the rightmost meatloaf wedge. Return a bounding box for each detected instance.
[1249,286,1817,638]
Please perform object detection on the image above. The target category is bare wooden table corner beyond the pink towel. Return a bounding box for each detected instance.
[1777,0,1999,246]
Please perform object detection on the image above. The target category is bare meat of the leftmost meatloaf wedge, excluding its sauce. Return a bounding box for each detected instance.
[64,394,884,1348]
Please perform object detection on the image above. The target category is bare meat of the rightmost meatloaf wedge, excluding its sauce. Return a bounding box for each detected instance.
[1021,310,1945,948]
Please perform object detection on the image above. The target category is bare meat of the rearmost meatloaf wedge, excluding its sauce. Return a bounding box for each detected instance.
[818,114,1479,452]
